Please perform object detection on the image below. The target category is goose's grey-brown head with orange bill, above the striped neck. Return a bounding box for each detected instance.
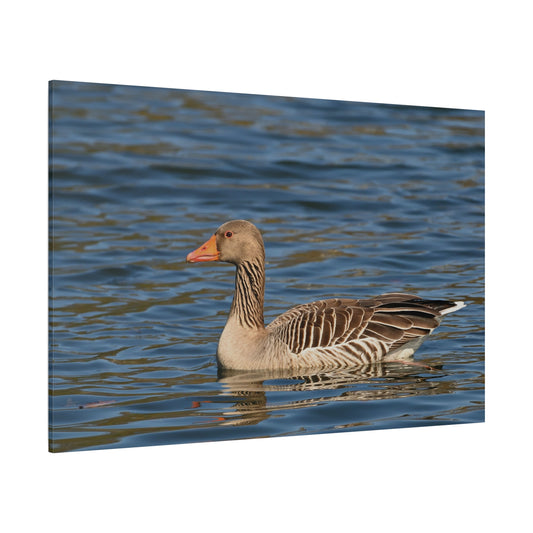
[187,220,265,265]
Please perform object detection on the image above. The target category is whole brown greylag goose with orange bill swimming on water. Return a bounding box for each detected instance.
[187,220,465,370]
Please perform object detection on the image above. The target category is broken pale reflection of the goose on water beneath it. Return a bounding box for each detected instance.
[214,362,451,426]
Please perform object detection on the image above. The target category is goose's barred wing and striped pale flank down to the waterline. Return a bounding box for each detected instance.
[267,293,450,367]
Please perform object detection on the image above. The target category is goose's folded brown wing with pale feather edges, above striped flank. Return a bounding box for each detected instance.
[268,293,455,354]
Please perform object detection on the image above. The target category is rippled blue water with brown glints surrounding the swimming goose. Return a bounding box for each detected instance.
[50,82,484,451]
